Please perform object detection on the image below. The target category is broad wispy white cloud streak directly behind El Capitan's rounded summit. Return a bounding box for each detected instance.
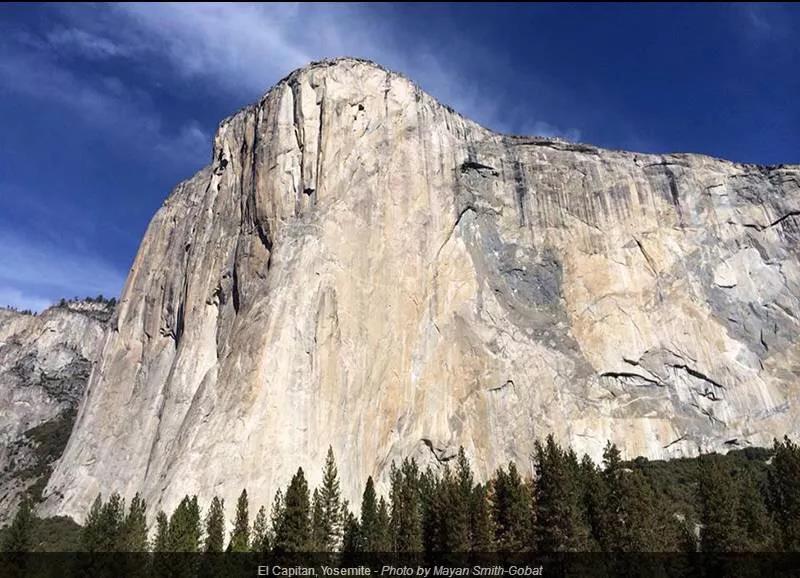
[53,3,579,139]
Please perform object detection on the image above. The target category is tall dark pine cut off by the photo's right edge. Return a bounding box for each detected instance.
[768,437,800,552]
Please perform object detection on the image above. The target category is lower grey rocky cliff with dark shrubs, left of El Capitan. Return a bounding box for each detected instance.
[0,301,112,523]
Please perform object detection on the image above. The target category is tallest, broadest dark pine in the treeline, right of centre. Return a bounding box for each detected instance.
[534,435,590,552]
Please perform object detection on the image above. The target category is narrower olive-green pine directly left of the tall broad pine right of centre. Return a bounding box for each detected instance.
[492,462,533,552]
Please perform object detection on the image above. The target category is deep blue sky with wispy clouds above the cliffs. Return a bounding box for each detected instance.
[0,4,800,310]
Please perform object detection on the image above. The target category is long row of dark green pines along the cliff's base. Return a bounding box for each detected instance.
[4,437,800,554]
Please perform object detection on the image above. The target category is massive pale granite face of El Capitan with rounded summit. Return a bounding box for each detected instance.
[43,59,800,519]
